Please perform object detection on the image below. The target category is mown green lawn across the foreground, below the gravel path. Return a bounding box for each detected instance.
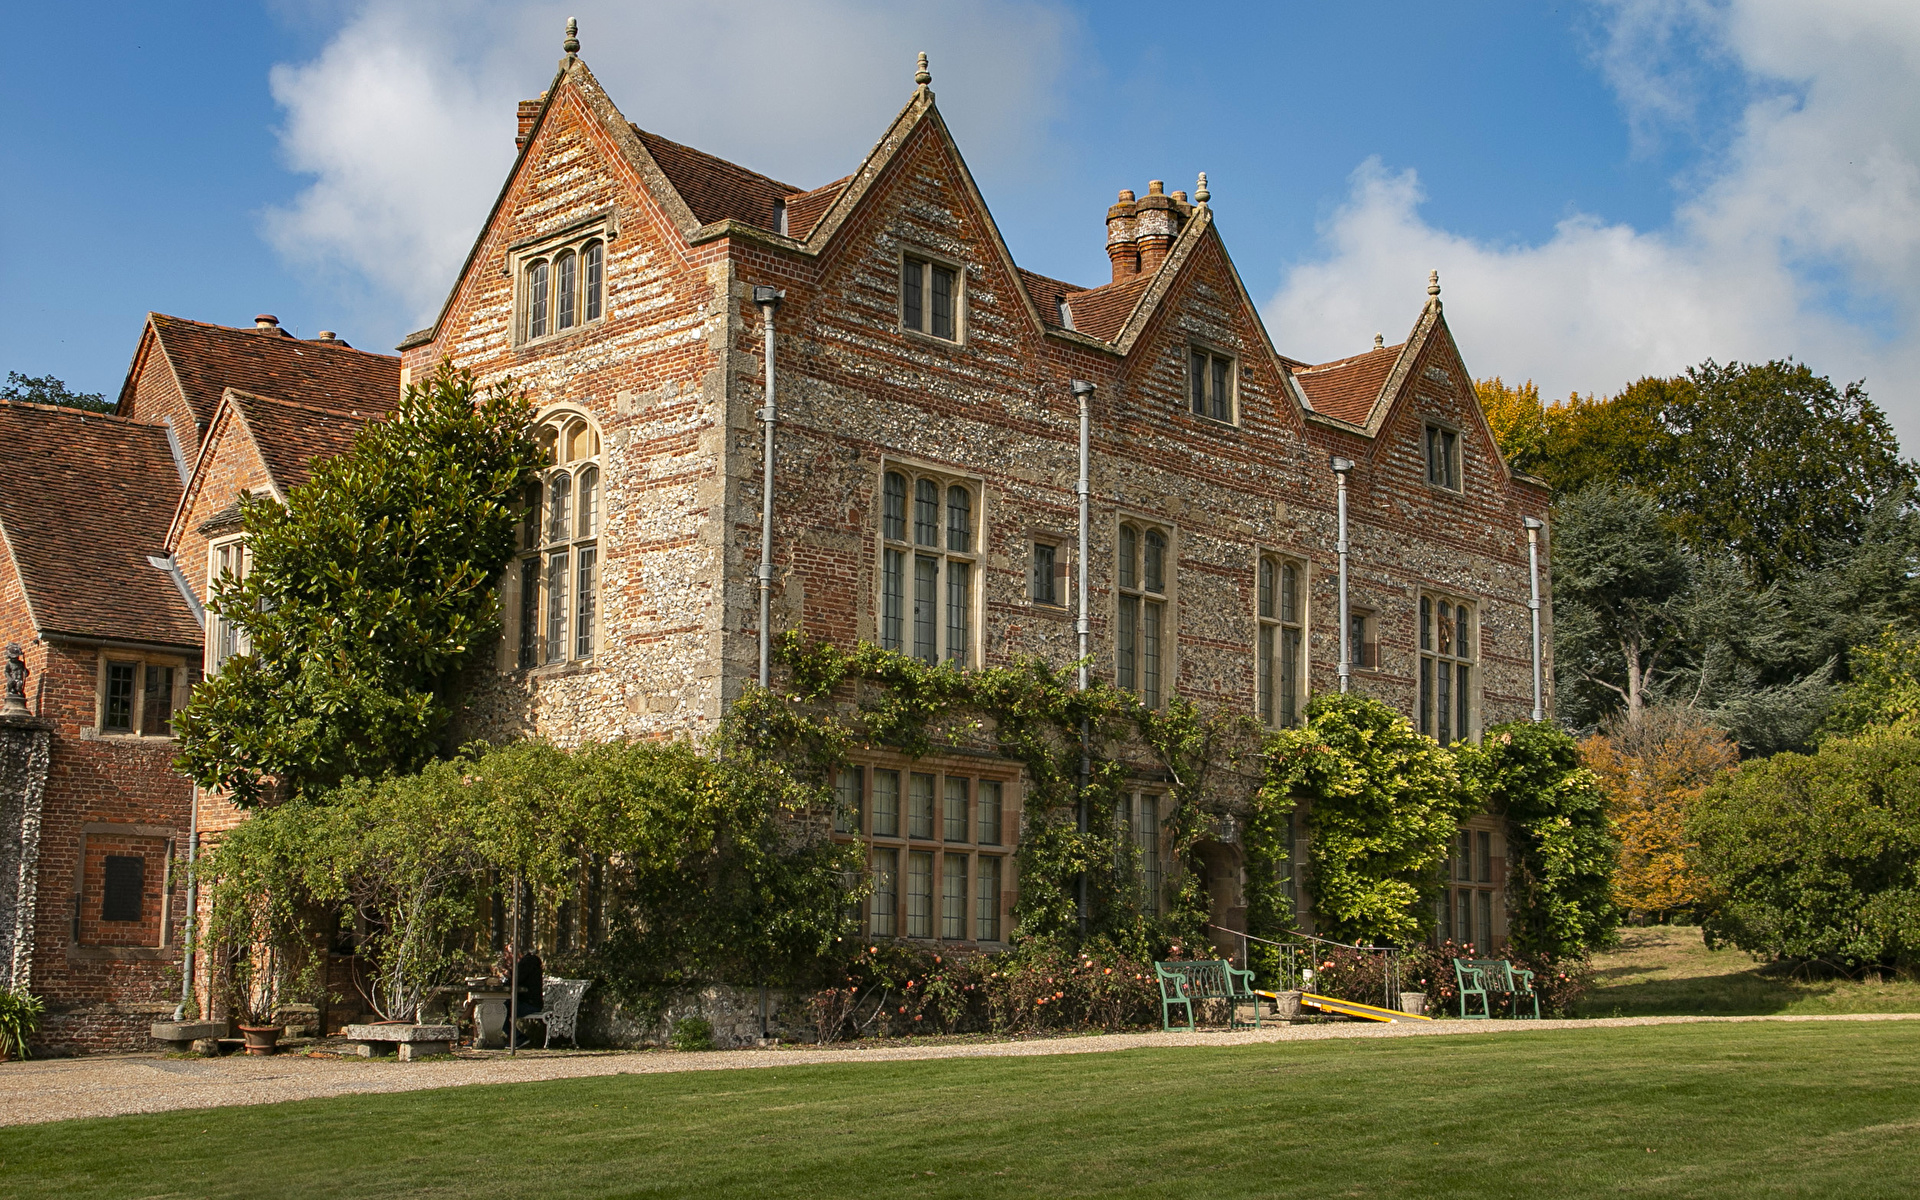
[0,1021,1920,1200]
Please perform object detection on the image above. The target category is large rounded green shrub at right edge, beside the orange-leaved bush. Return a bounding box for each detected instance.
[1688,732,1920,970]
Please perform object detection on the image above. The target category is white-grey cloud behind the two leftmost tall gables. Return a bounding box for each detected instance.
[265,0,1073,328]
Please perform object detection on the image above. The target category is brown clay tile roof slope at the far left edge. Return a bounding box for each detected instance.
[0,401,200,647]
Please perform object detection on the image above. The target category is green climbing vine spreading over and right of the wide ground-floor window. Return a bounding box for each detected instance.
[768,634,1258,945]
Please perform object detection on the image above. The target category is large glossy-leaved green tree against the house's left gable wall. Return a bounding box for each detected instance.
[177,365,540,806]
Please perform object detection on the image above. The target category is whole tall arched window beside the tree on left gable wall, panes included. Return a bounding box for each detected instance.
[507,411,601,668]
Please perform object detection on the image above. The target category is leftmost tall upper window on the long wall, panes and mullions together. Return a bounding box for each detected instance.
[879,470,979,666]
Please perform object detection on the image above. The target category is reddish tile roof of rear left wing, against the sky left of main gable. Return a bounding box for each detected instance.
[150,313,399,428]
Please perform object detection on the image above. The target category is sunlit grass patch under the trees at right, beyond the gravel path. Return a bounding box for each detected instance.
[1578,925,1920,1018]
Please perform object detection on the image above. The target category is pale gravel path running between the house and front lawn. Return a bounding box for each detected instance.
[0,1014,1920,1125]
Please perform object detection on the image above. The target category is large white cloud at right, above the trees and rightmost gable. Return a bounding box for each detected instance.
[1265,0,1920,445]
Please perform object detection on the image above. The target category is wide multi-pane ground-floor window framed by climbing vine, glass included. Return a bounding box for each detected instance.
[833,764,1014,943]
